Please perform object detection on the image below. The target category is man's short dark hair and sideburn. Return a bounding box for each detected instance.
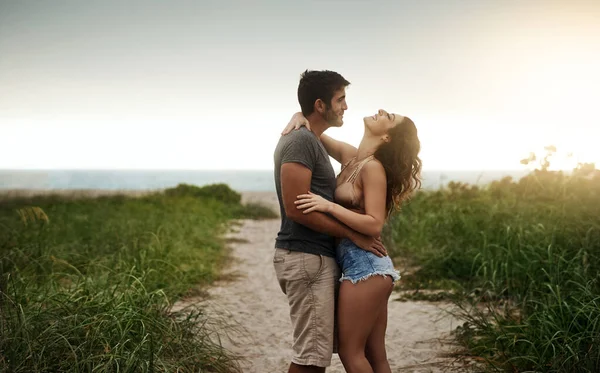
[298,70,350,117]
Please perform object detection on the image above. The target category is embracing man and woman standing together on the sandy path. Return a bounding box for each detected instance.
[273,71,421,373]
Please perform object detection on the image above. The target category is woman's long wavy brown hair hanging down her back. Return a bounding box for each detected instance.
[375,117,422,216]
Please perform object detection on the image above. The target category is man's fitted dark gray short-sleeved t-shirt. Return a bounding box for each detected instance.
[274,127,336,258]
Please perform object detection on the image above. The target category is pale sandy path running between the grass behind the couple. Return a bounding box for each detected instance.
[188,193,464,373]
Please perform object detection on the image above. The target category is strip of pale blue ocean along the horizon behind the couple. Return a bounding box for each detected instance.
[0,170,527,191]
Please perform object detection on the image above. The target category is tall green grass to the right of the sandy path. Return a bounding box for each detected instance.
[386,170,600,372]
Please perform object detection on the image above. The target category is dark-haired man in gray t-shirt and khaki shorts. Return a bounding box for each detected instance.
[273,70,385,373]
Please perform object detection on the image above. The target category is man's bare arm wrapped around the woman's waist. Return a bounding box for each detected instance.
[280,162,387,256]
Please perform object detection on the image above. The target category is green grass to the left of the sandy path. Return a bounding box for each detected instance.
[0,185,274,372]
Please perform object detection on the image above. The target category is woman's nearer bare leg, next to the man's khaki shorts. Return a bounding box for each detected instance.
[338,276,392,373]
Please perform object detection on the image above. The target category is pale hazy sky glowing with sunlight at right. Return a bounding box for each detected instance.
[0,0,600,170]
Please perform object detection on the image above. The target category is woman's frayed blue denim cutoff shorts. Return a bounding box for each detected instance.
[336,238,400,284]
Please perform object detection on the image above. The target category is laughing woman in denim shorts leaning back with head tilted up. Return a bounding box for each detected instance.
[283,110,421,373]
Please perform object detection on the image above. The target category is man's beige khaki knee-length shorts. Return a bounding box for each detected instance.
[273,249,340,367]
